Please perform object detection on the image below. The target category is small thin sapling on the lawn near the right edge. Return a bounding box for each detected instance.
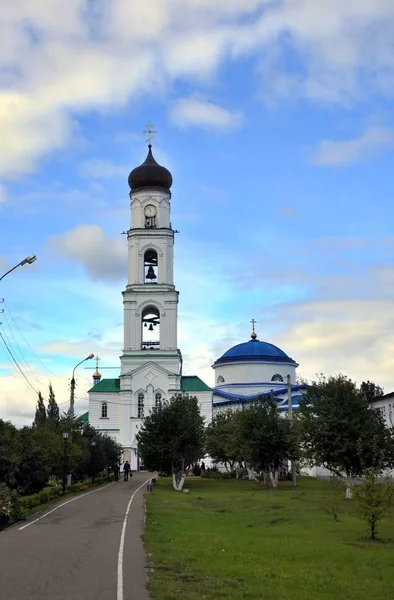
[354,469,394,540]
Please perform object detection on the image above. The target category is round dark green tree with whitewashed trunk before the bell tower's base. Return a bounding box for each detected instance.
[137,394,204,491]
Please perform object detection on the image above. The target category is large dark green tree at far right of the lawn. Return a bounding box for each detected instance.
[298,375,394,498]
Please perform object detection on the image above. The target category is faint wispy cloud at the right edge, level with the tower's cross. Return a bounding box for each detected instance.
[312,126,394,166]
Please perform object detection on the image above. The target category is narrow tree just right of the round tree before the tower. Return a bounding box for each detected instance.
[205,410,242,471]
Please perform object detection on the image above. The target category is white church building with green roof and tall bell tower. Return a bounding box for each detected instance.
[89,145,212,469]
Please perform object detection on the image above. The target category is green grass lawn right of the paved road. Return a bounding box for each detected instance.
[145,478,394,600]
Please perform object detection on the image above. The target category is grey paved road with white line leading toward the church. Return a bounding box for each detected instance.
[0,473,149,600]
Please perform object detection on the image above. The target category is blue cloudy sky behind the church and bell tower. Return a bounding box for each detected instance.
[0,0,394,426]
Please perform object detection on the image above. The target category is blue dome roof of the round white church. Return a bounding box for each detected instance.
[214,340,297,365]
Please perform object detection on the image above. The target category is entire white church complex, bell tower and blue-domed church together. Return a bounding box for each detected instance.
[87,139,304,470]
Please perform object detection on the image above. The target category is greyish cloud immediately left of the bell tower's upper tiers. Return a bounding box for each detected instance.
[51,225,127,281]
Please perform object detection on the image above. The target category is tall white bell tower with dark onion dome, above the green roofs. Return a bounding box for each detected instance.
[121,144,181,384]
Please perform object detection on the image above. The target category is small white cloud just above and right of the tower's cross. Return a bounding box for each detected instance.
[171,97,242,130]
